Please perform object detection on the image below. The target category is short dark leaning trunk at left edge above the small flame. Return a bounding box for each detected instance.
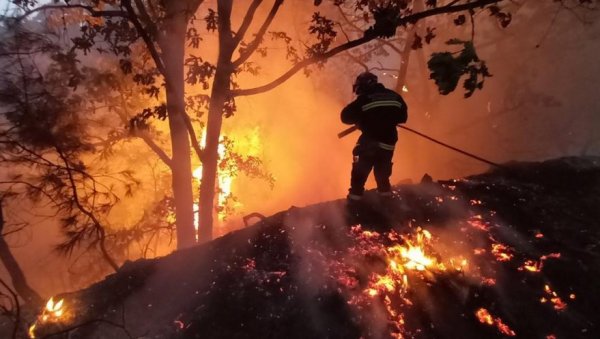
[0,200,42,304]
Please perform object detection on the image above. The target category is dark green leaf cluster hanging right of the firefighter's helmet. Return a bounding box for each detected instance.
[427,39,492,98]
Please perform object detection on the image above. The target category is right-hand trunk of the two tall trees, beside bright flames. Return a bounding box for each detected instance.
[198,0,235,242]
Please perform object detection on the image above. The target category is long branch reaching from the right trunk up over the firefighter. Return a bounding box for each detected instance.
[230,0,505,96]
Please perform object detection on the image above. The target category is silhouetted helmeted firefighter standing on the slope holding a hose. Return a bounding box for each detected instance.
[341,72,407,202]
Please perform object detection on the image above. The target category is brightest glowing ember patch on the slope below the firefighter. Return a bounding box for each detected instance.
[337,226,468,338]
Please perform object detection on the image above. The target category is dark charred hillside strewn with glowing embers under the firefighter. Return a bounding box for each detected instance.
[34,158,600,338]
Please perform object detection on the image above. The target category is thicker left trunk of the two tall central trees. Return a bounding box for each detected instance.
[160,1,196,249]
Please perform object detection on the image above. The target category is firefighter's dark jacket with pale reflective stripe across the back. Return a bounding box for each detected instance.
[341,83,407,149]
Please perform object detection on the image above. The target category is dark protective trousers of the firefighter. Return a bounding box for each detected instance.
[348,142,394,199]
